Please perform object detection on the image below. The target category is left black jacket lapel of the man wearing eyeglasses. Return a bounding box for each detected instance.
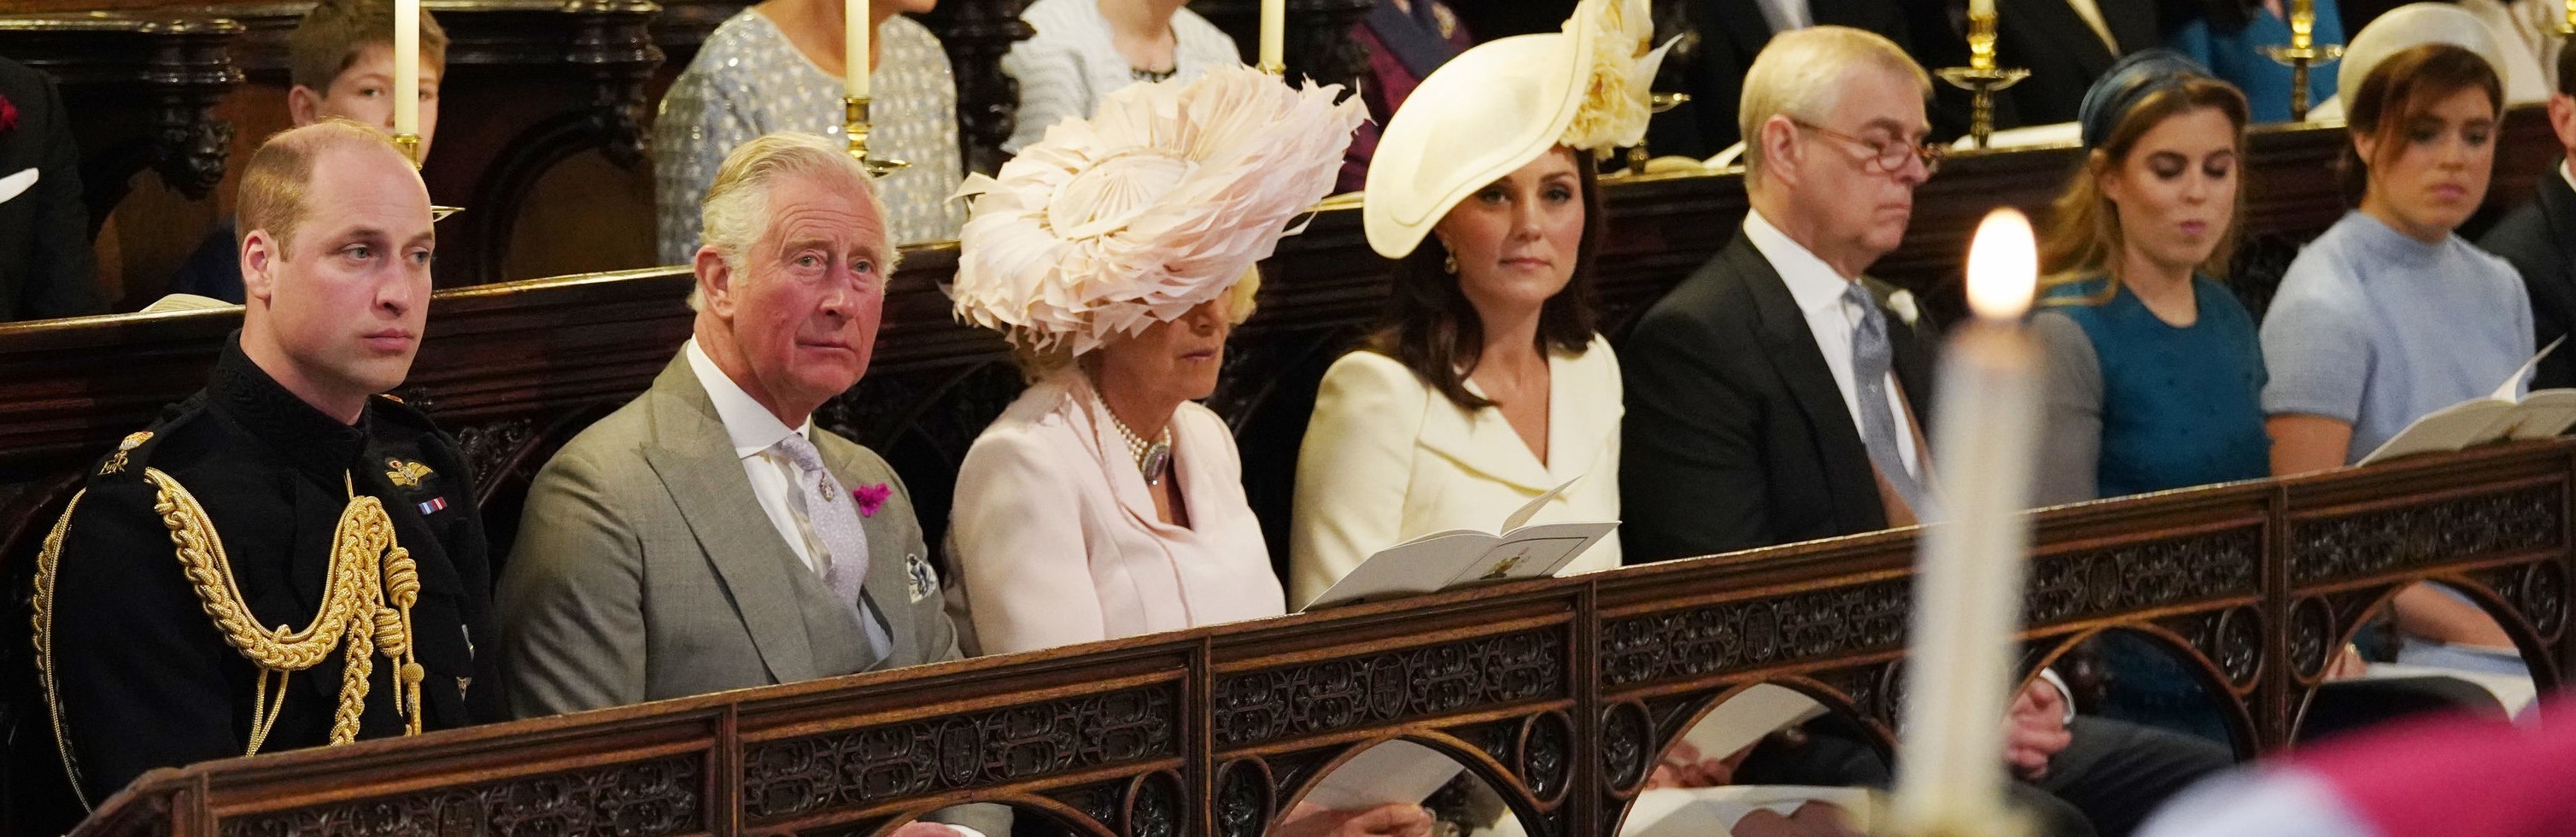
[1726,234,1886,530]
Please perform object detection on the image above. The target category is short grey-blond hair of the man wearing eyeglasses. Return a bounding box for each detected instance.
[1736,26,1932,183]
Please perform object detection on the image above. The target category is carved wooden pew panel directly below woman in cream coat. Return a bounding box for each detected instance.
[1214,629,1569,746]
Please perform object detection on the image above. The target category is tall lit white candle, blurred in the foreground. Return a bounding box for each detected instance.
[1894,208,2040,834]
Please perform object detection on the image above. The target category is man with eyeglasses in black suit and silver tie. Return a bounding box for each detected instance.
[1620,26,2223,837]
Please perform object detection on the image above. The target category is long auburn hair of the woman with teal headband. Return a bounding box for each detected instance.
[2040,77,2249,301]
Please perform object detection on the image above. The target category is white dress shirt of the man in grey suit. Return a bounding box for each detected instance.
[680,337,894,657]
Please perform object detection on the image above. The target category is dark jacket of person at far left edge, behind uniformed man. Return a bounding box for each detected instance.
[0,59,106,322]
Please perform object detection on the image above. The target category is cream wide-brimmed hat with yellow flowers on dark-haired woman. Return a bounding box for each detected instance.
[1360,0,1671,258]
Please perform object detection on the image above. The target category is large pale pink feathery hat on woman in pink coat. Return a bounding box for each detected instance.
[948,67,1367,355]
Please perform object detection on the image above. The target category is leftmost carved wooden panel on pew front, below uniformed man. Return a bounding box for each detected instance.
[216,755,708,837]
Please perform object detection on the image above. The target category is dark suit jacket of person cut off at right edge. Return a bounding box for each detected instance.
[2478,165,2576,389]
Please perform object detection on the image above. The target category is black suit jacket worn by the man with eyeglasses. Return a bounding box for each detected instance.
[1620,234,1932,564]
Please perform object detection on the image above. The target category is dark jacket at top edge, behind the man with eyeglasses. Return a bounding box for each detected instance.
[1646,0,1937,157]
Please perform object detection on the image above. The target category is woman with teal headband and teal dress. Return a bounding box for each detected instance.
[2033,49,2272,505]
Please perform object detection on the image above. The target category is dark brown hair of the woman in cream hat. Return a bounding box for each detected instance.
[1360,152,1607,409]
